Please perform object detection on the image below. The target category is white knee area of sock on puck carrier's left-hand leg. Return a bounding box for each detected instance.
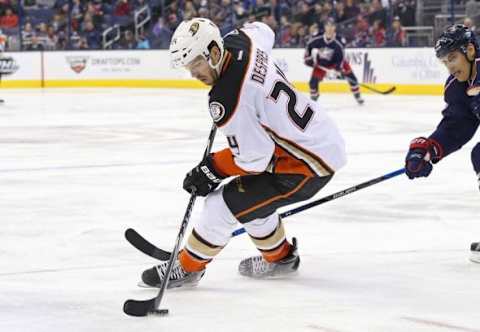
[190,188,237,246]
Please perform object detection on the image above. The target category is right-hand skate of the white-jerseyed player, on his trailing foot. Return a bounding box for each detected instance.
[238,238,300,279]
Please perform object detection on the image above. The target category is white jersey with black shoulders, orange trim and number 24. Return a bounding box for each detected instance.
[209,22,346,176]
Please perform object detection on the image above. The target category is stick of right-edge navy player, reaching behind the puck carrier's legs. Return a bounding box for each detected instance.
[125,168,405,261]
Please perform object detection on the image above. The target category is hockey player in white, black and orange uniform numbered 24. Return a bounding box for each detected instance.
[142,18,346,287]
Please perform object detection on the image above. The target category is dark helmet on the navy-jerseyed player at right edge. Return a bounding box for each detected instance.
[435,24,478,58]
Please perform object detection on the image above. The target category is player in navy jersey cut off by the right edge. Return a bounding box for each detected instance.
[405,24,480,263]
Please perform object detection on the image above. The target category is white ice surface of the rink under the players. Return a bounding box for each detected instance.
[0,89,480,332]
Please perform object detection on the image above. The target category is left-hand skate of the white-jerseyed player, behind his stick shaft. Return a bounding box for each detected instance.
[138,260,205,288]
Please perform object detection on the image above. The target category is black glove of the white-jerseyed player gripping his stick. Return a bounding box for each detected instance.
[183,154,225,196]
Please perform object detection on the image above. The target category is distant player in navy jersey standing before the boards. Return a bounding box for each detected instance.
[304,19,363,105]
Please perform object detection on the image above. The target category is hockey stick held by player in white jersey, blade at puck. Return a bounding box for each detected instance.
[123,123,217,317]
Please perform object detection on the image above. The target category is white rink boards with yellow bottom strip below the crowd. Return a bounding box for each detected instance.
[1,48,448,95]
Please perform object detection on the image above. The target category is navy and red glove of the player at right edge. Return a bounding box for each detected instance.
[405,137,442,179]
